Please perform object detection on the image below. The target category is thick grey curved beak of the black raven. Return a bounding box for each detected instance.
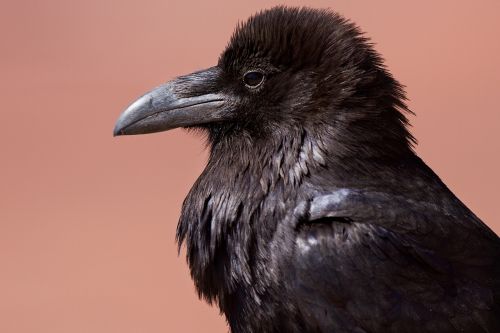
[113,67,230,136]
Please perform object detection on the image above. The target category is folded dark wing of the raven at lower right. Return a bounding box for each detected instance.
[290,189,500,332]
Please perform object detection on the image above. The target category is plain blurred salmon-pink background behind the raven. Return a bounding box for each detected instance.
[0,0,500,333]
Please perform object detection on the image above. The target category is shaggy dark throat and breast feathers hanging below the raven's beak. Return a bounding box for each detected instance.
[177,126,326,302]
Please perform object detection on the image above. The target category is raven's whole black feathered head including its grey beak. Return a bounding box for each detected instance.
[114,7,413,158]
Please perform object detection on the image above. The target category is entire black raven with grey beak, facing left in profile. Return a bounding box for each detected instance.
[114,7,500,333]
